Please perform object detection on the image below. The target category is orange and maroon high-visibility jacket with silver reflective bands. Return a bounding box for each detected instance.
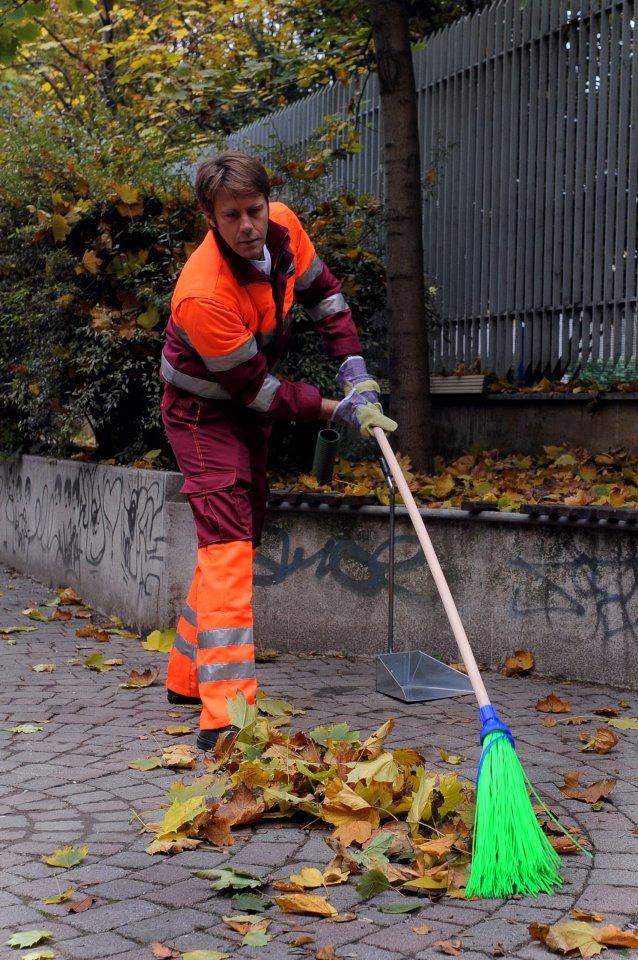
[161,203,361,421]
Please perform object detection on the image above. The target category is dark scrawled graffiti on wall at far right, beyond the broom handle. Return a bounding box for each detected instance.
[511,548,638,642]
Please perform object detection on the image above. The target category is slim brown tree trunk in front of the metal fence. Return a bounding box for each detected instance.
[369,0,432,472]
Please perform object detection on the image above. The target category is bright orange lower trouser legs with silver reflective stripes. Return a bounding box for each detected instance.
[166,540,257,730]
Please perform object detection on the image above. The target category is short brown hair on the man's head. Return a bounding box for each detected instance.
[195,150,270,216]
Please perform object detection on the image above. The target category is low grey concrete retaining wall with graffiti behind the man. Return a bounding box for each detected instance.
[0,457,638,689]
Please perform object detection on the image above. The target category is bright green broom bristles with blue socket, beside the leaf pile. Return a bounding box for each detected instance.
[465,706,563,897]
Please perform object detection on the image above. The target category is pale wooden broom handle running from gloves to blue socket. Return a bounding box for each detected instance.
[372,427,490,707]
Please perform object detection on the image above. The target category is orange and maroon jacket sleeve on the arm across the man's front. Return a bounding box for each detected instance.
[174,297,321,422]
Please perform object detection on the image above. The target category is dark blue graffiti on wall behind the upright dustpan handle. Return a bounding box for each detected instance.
[255,527,423,596]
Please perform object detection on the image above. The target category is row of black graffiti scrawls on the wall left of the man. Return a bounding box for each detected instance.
[0,463,164,597]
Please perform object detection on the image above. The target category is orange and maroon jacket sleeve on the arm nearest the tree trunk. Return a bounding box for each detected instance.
[290,211,361,358]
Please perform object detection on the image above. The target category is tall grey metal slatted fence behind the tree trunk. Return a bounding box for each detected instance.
[228,0,638,378]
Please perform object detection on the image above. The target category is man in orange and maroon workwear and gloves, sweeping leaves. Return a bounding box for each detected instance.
[161,151,396,749]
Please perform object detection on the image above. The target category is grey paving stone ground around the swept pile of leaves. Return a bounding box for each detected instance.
[0,566,638,960]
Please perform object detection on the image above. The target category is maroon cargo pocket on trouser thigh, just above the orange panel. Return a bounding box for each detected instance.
[180,469,252,547]
